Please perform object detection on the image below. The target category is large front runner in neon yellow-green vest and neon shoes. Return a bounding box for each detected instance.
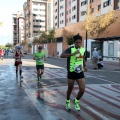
[60,34,87,111]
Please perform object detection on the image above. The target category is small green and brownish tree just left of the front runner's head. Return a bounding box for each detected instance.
[63,28,74,46]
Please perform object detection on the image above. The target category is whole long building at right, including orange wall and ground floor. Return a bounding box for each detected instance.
[49,0,120,60]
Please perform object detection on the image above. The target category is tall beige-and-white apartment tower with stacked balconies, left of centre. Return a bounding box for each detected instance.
[23,0,53,40]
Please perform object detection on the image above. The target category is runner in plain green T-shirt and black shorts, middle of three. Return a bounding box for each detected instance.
[33,46,46,82]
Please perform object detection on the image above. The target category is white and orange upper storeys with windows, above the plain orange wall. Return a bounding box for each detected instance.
[54,0,120,29]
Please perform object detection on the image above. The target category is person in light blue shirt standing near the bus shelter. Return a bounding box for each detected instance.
[92,48,99,69]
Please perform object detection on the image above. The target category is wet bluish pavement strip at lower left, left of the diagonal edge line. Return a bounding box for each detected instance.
[0,60,43,120]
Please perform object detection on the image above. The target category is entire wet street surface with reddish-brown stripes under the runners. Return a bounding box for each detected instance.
[0,54,120,120]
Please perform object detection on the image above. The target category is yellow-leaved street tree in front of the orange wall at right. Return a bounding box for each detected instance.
[81,9,117,38]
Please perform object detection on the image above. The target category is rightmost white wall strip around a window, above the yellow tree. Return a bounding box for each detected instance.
[101,0,114,14]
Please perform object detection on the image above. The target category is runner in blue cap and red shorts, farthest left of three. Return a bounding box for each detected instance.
[13,46,24,79]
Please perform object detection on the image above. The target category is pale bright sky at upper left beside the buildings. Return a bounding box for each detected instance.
[0,0,27,45]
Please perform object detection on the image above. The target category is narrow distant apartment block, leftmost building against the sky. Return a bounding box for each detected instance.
[12,11,24,45]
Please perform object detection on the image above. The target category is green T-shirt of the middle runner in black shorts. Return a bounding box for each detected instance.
[34,51,45,65]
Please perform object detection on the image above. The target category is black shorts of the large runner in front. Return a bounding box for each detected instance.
[67,71,84,80]
